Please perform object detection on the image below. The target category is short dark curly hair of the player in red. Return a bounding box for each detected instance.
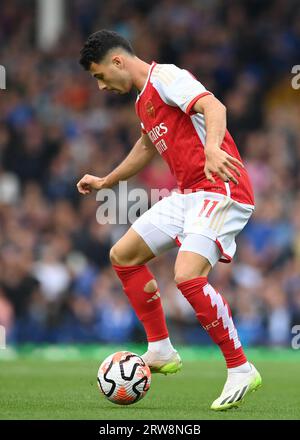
[79,29,134,70]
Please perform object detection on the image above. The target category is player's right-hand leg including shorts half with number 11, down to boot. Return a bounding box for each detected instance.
[175,192,262,411]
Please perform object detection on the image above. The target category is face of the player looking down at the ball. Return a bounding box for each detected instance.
[90,55,132,94]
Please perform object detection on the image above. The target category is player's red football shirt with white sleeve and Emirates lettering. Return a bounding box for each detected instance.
[136,62,254,205]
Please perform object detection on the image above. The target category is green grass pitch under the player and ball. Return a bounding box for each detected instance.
[0,347,300,420]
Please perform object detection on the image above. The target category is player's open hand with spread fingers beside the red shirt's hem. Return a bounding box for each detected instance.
[204,148,244,184]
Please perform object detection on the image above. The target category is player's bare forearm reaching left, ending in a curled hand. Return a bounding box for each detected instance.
[77,134,157,194]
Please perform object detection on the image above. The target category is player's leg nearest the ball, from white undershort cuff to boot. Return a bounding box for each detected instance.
[110,221,181,374]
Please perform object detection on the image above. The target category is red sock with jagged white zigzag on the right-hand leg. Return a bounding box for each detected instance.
[177,277,247,368]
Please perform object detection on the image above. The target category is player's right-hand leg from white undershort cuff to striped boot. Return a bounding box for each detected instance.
[175,234,261,410]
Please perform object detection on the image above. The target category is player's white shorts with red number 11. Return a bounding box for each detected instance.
[132,191,254,266]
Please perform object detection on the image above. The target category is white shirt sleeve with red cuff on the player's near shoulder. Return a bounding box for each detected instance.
[151,64,212,114]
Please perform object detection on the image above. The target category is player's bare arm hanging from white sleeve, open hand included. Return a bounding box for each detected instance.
[193,95,244,184]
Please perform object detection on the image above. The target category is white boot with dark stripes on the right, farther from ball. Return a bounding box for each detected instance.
[210,364,262,411]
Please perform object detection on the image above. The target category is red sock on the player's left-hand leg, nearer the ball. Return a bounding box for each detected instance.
[113,265,169,342]
